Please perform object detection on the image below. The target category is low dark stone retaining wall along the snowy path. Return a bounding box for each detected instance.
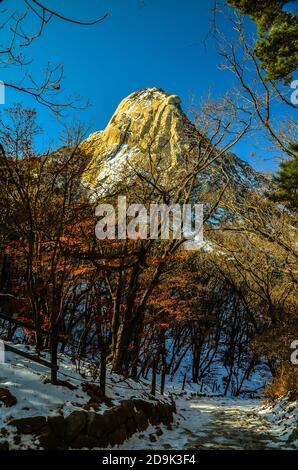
[9,399,176,450]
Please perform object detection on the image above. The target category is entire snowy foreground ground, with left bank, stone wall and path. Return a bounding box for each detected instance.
[0,345,298,450]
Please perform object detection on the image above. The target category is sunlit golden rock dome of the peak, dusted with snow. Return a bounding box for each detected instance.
[81,88,196,195]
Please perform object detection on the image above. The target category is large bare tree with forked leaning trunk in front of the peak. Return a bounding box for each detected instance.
[68,92,251,372]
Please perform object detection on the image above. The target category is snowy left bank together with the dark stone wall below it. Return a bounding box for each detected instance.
[0,345,172,450]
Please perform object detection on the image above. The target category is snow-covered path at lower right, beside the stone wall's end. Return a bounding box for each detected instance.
[120,397,298,450]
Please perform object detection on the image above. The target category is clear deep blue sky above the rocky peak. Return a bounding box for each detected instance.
[0,0,294,170]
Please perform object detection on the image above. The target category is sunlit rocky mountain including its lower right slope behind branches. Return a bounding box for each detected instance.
[81,88,263,196]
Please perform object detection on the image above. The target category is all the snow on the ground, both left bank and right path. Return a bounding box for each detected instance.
[0,345,298,450]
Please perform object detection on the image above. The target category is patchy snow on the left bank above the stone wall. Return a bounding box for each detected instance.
[0,345,157,449]
